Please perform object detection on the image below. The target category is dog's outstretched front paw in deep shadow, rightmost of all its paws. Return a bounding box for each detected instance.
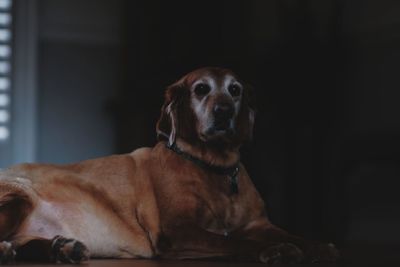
[306,243,340,263]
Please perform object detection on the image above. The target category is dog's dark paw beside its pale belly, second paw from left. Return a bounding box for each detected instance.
[51,236,90,263]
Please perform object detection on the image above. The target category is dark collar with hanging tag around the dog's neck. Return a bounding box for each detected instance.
[166,142,240,194]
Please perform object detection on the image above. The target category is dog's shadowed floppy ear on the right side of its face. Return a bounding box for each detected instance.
[237,84,256,143]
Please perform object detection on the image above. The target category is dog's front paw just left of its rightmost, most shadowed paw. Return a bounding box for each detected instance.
[260,243,304,265]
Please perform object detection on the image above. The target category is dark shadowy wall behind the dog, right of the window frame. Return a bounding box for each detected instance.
[14,0,400,264]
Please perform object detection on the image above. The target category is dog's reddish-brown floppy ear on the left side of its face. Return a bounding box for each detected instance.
[156,80,184,145]
